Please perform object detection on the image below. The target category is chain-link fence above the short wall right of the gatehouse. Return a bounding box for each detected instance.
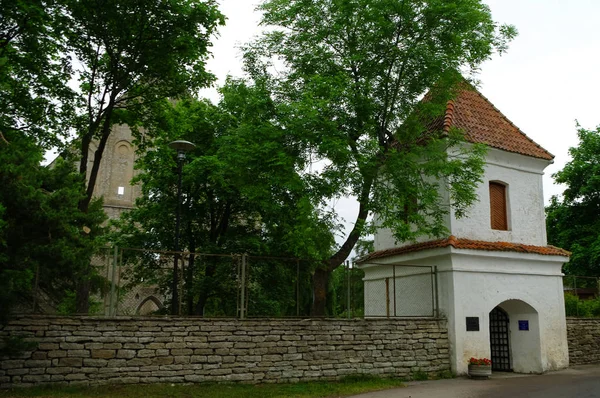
[563,275,600,317]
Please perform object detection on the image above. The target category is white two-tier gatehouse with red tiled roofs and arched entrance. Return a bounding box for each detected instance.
[359,88,569,374]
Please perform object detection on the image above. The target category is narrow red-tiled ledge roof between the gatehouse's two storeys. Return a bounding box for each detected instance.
[359,235,571,263]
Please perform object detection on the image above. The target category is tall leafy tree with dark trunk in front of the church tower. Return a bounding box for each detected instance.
[56,0,224,312]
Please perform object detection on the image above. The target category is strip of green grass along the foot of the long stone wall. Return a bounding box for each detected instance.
[0,375,402,398]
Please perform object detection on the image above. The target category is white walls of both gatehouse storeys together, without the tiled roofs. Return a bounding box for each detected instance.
[362,148,569,374]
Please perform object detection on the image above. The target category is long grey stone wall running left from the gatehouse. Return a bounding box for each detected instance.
[0,315,450,388]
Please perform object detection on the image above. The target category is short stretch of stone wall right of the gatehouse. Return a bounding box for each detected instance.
[567,318,600,366]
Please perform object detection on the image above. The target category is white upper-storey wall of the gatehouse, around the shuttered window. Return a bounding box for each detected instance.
[375,148,550,250]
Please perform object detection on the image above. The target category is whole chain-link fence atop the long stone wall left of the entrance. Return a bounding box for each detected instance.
[25,247,446,319]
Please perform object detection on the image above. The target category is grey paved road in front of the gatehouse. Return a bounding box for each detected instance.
[355,365,600,398]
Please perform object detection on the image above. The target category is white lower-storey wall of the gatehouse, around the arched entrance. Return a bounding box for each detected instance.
[363,247,569,374]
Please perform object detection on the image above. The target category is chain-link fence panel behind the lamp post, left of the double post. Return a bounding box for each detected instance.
[103,248,244,317]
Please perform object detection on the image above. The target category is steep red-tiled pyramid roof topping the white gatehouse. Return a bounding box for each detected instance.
[428,84,554,160]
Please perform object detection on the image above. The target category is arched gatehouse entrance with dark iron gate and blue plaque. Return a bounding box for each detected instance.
[490,300,543,373]
